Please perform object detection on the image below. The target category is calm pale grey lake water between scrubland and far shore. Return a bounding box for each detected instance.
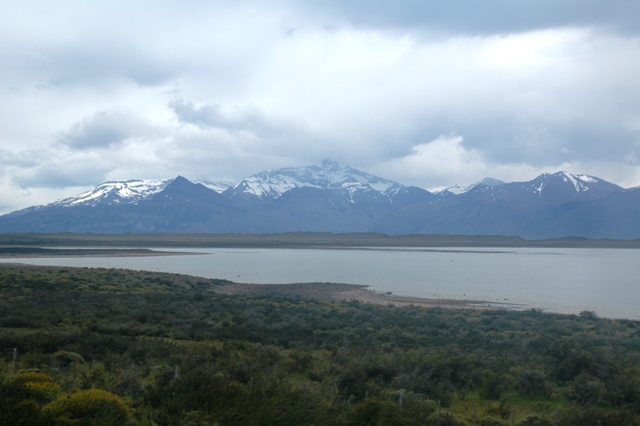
[2,248,640,319]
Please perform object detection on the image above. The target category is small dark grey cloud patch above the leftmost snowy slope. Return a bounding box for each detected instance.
[58,111,144,149]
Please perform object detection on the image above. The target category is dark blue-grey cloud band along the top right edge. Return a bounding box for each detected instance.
[298,0,640,35]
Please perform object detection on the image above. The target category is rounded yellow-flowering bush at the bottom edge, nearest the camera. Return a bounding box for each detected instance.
[42,389,131,425]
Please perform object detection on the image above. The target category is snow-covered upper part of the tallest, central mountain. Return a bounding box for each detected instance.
[225,160,416,202]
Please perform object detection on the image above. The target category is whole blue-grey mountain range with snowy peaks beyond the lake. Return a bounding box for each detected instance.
[0,160,640,239]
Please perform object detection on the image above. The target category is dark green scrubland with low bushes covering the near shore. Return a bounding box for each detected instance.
[0,266,640,426]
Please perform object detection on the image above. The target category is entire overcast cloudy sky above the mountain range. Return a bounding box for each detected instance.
[0,0,640,214]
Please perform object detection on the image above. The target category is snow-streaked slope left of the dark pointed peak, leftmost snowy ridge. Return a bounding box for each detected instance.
[49,179,173,207]
